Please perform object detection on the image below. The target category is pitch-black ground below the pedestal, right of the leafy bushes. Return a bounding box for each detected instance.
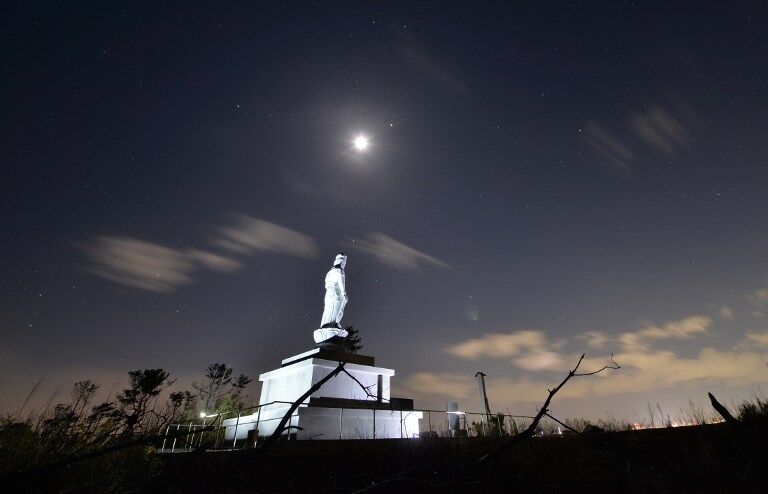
[150,424,768,493]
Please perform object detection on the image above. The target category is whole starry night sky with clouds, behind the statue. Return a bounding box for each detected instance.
[0,2,768,419]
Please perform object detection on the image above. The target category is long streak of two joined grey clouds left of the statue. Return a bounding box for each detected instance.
[81,215,317,293]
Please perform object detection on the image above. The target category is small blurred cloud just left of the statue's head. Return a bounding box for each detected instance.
[213,215,318,258]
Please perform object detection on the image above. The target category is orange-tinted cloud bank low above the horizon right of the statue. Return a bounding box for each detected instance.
[406,315,768,404]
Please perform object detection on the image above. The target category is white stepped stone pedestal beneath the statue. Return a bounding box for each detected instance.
[223,348,422,441]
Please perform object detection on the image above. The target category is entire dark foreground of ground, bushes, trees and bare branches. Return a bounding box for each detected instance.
[0,356,768,494]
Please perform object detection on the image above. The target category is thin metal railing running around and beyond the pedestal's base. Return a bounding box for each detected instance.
[159,401,533,453]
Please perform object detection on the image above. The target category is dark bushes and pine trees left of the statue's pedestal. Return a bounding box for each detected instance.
[0,363,251,492]
